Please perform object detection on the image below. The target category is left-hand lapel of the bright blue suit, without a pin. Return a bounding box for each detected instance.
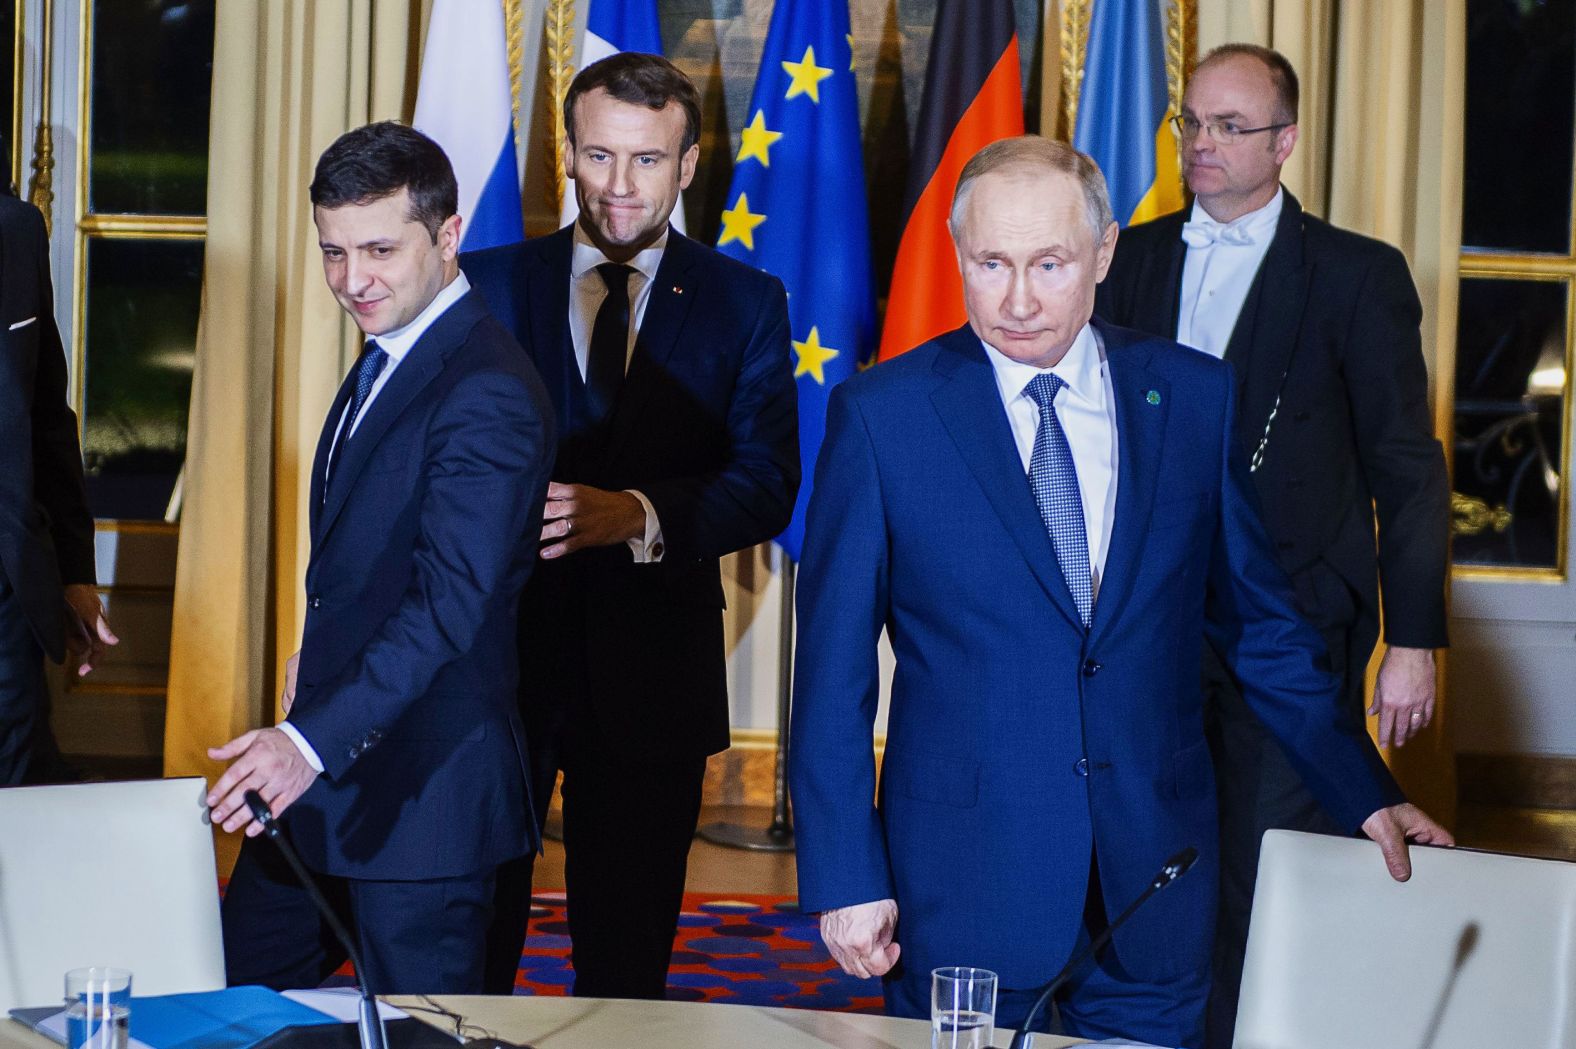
[930,328,1083,630]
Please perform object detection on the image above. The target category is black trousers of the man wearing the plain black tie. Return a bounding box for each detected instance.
[485,718,706,999]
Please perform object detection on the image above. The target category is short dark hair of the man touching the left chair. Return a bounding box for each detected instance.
[310,120,460,244]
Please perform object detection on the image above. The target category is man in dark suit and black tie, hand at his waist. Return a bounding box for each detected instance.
[462,54,799,999]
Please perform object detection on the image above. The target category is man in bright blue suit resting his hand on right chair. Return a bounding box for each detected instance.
[790,137,1450,1046]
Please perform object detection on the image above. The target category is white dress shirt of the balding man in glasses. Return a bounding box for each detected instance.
[1177,189,1286,358]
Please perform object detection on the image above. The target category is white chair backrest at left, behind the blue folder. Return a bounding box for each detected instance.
[0,778,224,1017]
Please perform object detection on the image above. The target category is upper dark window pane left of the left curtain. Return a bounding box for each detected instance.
[89,0,214,214]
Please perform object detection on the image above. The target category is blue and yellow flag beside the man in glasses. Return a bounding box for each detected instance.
[1073,0,1182,225]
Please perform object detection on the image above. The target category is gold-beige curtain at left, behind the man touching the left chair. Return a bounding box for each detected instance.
[164,0,424,869]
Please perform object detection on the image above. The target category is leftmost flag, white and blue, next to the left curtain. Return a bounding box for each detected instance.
[414,0,525,252]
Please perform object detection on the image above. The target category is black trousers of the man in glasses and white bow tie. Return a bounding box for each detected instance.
[1204,607,1376,1049]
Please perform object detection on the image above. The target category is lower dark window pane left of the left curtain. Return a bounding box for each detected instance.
[82,238,203,520]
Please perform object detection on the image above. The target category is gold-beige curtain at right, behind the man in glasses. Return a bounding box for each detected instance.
[1198,0,1466,824]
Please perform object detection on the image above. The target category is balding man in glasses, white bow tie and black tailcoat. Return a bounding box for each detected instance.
[1097,44,1450,1046]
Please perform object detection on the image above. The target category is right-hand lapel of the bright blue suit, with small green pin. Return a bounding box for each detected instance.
[1089,321,1171,643]
